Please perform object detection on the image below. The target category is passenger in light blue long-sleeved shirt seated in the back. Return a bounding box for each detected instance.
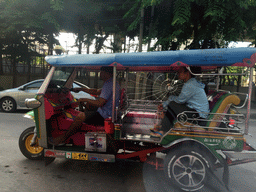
[150,67,210,138]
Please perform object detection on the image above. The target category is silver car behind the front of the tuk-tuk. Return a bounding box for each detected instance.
[0,79,94,113]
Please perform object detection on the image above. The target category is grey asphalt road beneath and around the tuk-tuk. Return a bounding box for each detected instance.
[0,110,256,192]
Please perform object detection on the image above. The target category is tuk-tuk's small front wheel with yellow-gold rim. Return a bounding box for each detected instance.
[19,126,44,160]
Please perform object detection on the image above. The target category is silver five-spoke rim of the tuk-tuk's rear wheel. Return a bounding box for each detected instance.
[169,155,206,188]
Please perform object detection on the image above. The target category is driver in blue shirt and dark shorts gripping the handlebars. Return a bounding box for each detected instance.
[49,66,120,145]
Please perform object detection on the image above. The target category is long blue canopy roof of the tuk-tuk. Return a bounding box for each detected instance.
[46,48,256,67]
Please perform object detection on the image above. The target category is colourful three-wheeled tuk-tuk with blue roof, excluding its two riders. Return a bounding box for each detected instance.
[19,48,256,191]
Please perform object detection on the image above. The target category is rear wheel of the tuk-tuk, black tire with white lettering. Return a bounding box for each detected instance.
[164,145,211,191]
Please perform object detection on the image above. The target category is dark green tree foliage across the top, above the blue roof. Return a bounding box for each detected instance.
[0,0,256,65]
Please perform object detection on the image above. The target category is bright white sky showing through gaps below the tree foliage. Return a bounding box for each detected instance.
[56,33,251,55]
